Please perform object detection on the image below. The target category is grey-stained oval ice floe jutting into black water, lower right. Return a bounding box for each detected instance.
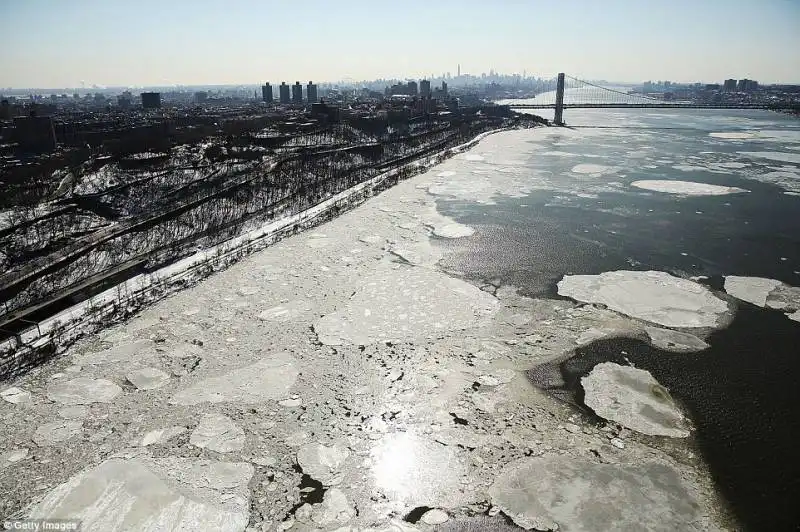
[581,362,689,438]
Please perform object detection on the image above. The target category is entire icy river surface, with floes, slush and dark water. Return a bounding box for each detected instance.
[0,111,800,532]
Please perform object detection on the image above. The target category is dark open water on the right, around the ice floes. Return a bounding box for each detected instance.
[432,111,800,530]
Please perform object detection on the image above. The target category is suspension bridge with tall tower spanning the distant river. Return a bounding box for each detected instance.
[509,73,798,125]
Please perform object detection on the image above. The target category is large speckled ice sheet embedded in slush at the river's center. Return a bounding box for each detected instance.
[314,267,499,345]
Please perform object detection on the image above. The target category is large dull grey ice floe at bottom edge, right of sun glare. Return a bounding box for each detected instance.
[489,456,698,532]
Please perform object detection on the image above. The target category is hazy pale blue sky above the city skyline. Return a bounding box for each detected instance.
[0,0,800,88]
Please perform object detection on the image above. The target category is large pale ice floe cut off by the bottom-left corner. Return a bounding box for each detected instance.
[29,458,254,532]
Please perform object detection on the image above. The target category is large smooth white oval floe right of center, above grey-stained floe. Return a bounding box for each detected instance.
[558,270,729,328]
